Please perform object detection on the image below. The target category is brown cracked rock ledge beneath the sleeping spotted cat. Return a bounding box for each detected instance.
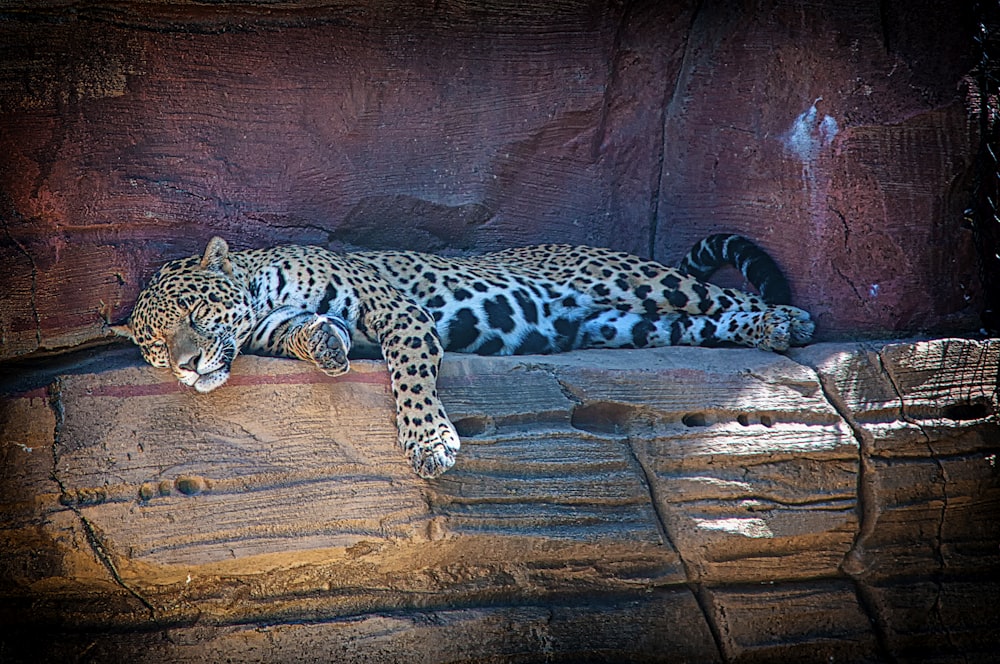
[0,339,1000,662]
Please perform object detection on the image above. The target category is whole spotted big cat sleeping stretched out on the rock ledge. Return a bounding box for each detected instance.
[112,234,814,478]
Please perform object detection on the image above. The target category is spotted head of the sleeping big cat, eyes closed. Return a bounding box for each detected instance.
[112,237,256,392]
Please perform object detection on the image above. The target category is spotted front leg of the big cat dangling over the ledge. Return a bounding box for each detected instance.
[362,296,461,479]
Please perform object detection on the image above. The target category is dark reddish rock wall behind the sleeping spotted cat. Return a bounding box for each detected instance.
[0,0,980,357]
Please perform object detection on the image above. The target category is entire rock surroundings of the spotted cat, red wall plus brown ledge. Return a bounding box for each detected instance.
[0,0,1000,662]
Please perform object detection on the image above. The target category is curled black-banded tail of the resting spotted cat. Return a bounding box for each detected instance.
[678,233,792,304]
